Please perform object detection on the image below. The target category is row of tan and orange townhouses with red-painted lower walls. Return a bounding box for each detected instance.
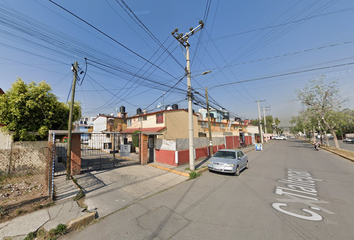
[81,105,258,165]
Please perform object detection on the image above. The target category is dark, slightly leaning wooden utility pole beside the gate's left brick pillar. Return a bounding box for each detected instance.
[66,62,78,180]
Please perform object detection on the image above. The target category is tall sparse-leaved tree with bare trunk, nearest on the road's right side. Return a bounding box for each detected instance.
[296,77,349,149]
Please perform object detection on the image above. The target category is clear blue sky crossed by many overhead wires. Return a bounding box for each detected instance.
[0,0,354,125]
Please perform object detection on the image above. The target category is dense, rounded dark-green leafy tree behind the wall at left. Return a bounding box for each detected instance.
[0,78,81,141]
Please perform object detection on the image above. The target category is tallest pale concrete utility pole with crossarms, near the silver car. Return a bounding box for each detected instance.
[171,20,204,171]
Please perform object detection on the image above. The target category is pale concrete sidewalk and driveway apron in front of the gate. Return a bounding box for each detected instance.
[0,146,254,239]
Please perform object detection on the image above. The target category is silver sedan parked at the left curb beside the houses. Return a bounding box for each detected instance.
[208,149,249,176]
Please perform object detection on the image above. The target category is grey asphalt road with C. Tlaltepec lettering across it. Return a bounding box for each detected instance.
[62,139,354,240]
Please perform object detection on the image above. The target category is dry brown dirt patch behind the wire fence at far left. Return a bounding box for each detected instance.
[0,175,53,223]
